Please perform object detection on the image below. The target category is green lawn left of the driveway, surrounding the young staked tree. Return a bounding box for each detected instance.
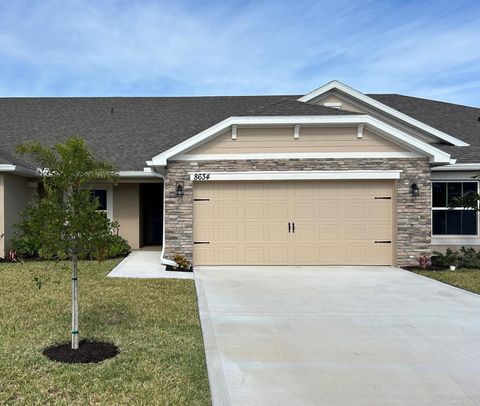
[0,260,210,405]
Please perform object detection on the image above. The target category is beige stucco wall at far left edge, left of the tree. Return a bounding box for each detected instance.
[0,174,36,257]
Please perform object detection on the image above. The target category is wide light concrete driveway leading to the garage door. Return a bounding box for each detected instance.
[195,267,480,406]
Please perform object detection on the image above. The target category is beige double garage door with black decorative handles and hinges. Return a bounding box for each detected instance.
[194,180,394,265]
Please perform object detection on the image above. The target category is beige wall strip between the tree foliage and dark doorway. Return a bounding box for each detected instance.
[113,183,140,249]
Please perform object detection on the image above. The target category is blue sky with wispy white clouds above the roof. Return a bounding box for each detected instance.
[0,0,480,107]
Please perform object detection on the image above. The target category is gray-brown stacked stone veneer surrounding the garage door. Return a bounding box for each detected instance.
[164,158,431,266]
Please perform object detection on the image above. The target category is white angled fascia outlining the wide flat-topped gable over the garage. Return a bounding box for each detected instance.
[147,114,450,167]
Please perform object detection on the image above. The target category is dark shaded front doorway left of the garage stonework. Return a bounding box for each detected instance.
[140,183,163,245]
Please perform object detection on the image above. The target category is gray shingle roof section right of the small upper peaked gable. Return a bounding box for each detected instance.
[368,94,480,163]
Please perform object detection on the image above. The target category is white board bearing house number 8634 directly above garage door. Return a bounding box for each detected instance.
[189,170,402,182]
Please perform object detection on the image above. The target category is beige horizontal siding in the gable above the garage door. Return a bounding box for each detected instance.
[187,126,407,154]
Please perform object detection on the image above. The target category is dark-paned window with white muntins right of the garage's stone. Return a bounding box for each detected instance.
[432,182,478,235]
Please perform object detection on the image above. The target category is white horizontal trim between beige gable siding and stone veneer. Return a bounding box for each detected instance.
[175,152,423,161]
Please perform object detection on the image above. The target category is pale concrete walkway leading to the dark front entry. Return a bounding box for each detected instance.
[108,250,193,279]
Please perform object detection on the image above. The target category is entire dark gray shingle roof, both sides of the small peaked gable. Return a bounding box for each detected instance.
[0,95,480,170]
